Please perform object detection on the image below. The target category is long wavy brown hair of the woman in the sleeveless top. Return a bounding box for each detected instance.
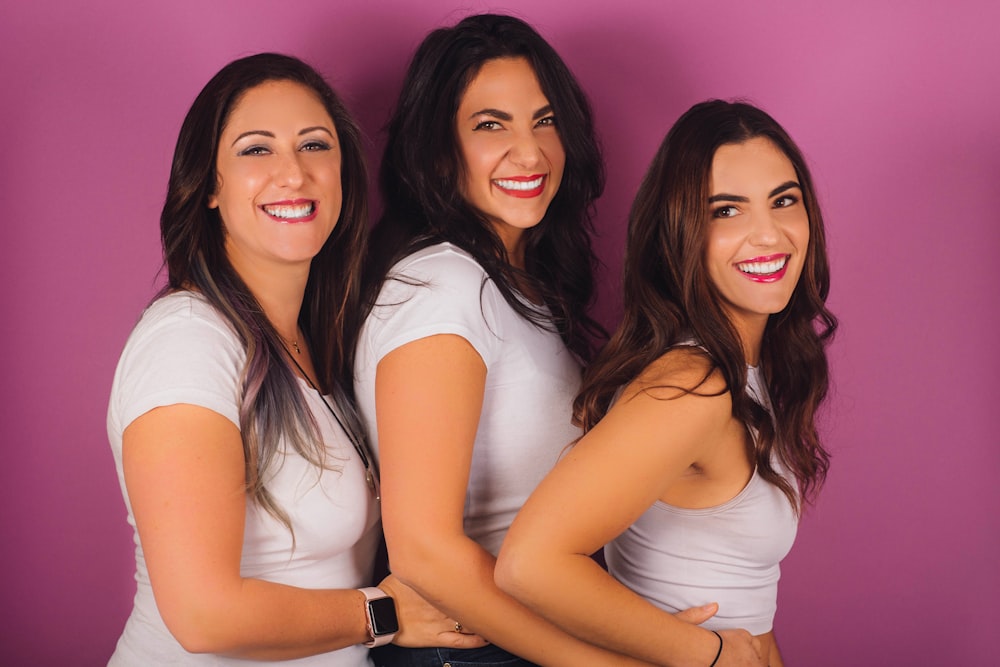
[574,100,837,510]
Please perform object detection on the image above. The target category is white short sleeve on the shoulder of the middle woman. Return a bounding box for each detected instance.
[366,244,503,368]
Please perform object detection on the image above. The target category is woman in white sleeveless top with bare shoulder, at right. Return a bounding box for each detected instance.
[497,100,836,667]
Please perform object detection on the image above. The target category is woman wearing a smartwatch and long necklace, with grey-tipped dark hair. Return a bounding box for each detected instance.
[108,54,482,667]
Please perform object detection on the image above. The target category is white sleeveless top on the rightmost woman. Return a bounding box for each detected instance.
[604,367,798,635]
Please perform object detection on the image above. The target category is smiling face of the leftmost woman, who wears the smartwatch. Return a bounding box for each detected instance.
[208,81,342,275]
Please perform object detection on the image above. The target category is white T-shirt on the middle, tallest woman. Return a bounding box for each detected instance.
[355,243,580,555]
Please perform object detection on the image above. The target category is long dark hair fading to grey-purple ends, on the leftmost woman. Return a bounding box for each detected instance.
[160,53,368,526]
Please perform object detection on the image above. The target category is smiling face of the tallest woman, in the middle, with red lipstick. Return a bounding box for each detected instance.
[455,58,566,262]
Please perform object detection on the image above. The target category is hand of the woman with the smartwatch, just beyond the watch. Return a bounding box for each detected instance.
[378,574,489,648]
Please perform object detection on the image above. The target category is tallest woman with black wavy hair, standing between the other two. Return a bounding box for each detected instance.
[355,14,708,667]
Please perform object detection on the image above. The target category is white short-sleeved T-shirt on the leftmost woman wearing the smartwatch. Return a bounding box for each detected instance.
[108,292,381,667]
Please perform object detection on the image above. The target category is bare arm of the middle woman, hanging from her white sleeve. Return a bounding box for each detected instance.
[375,335,656,666]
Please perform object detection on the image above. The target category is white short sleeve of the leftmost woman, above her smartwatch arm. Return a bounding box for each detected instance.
[109,293,246,436]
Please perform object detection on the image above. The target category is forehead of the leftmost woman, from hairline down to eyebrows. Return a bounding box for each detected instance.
[222,81,333,135]
